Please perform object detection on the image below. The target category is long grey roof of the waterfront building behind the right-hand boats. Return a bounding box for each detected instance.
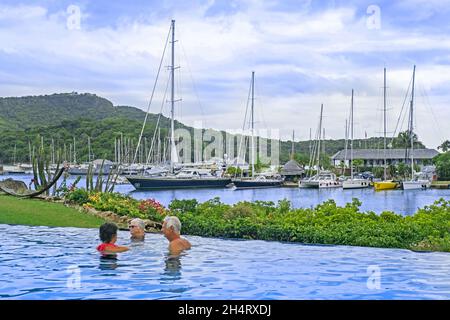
[331,149,439,160]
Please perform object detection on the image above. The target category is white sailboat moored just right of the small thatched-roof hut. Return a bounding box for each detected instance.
[298,104,342,189]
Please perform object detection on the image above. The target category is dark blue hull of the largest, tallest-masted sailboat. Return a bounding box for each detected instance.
[126,176,231,190]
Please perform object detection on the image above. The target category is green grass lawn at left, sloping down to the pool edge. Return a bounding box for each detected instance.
[0,194,104,228]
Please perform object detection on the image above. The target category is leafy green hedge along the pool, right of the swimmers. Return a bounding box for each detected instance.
[170,198,450,251]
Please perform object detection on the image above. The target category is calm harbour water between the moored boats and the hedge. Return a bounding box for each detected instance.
[0,176,450,215]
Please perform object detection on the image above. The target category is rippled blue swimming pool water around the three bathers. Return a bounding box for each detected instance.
[0,225,450,299]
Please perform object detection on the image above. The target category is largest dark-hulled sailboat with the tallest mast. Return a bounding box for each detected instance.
[125,20,231,190]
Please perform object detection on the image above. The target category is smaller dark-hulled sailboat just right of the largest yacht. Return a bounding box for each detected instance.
[231,71,283,189]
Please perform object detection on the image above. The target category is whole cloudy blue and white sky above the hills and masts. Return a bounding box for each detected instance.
[0,0,450,147]
